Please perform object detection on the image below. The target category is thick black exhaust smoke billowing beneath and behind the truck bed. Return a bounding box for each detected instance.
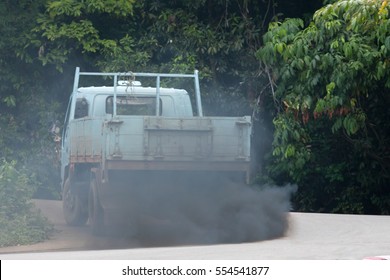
[106,173,295,246]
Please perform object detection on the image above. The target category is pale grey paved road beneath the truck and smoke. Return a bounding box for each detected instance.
[0,201,390,260]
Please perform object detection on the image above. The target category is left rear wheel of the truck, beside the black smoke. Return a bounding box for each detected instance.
[88,179,104,235]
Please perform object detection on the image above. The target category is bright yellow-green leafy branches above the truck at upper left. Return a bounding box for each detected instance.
[23,0,135,71]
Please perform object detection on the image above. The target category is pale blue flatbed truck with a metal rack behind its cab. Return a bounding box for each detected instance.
[60,67,252,234]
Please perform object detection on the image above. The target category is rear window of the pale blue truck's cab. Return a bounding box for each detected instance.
[106,96,162,116]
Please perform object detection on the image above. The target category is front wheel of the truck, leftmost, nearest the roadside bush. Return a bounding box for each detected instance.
[62,178,88,226]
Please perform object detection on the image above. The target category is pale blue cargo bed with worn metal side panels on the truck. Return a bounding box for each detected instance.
[70,116,251,171]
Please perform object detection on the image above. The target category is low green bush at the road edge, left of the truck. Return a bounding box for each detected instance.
[0,160,52,247]
